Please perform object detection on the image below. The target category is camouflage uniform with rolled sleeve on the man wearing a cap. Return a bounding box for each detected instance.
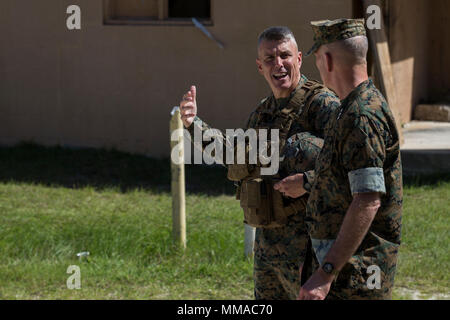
[306,20,403,299]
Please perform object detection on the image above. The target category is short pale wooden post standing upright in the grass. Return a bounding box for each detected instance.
[170,110,186,249]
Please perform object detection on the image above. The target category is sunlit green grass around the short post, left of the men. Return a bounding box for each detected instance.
[0,183,251,299]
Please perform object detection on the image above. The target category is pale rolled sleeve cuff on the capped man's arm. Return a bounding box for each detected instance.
[348,168,386,194]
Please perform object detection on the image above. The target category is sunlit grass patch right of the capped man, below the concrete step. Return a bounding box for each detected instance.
[390,176,450,299]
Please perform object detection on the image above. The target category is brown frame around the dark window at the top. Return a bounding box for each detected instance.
[103,0,215,26]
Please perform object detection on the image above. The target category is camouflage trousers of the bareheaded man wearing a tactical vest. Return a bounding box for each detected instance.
[253,214,309,300]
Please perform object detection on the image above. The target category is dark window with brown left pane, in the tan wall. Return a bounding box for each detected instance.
[104,0,212,25]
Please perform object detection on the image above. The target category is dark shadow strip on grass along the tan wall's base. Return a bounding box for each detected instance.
[0,143,234,195]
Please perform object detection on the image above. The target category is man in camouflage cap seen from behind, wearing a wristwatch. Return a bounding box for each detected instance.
[299,19,403,300]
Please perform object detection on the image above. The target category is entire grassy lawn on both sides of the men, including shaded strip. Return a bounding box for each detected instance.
[0,145,450,299]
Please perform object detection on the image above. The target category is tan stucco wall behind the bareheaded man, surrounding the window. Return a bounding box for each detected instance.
[0,0,351,156]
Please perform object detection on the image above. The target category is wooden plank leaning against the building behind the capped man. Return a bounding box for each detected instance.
[363,0,404,145]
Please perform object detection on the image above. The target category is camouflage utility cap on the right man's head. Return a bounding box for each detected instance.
[306,19,366,56]
